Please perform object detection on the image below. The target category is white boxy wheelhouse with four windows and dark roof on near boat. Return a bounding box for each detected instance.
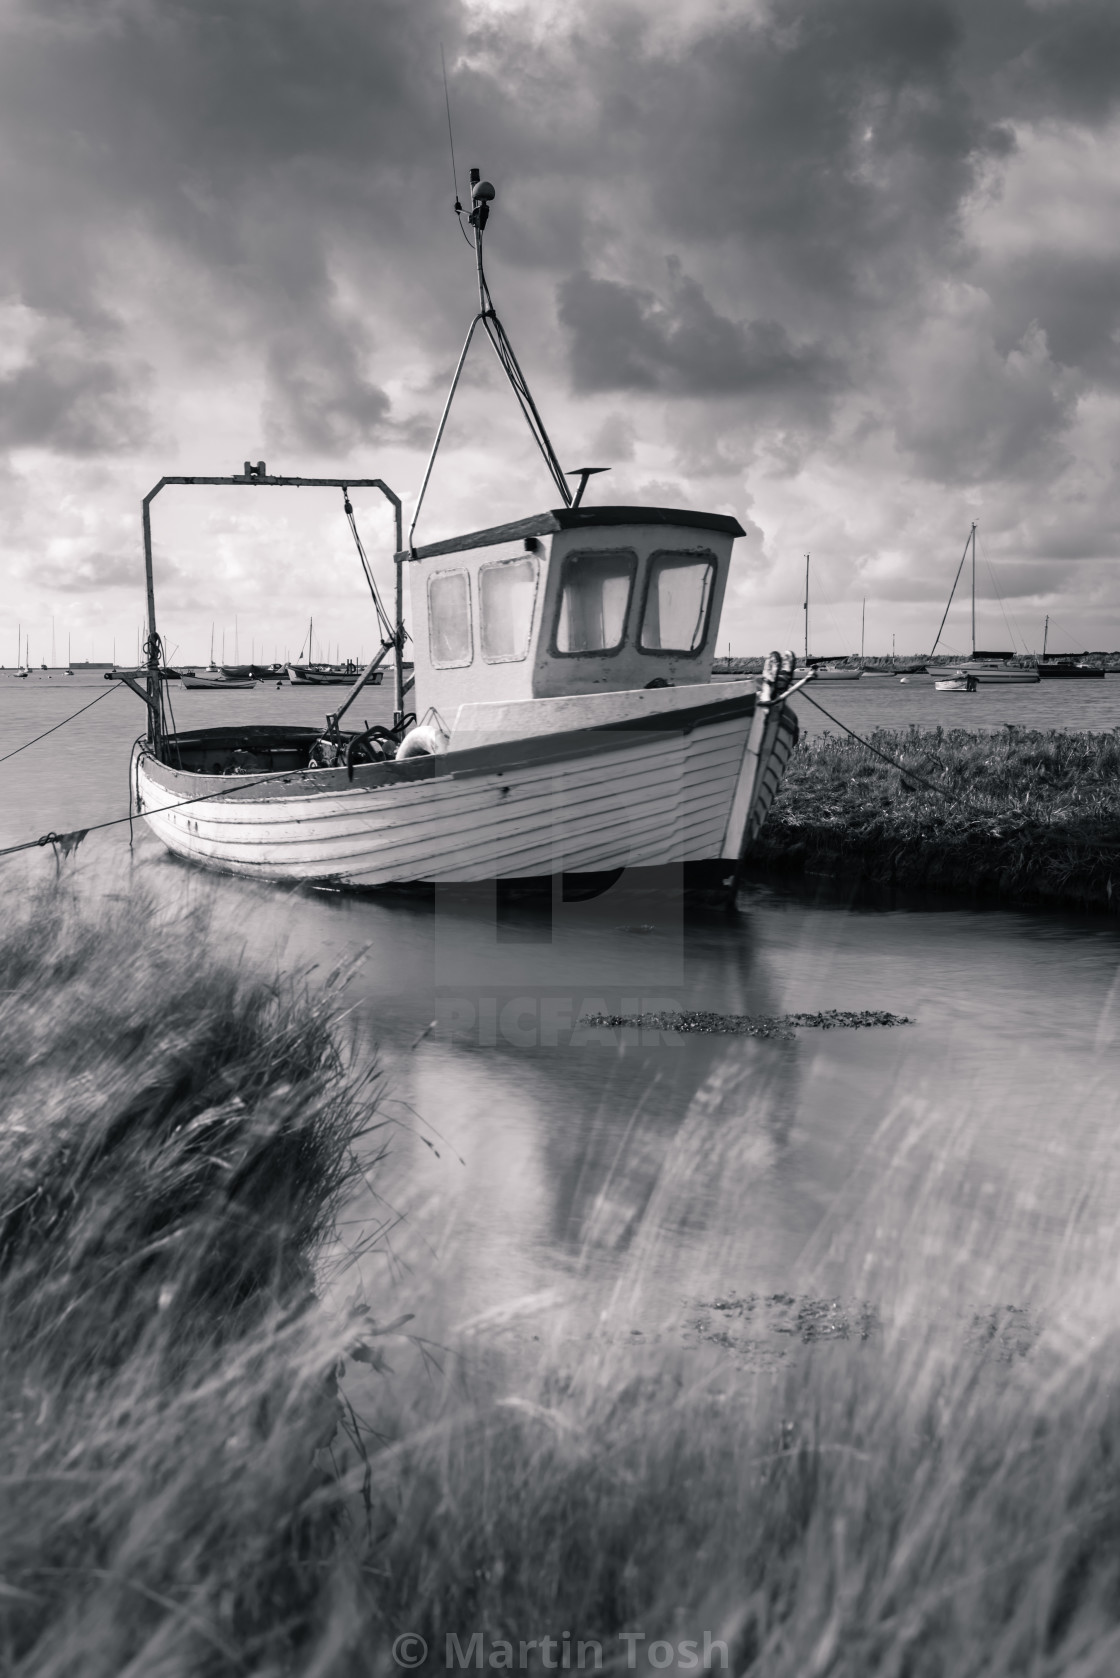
[401,507,744,722]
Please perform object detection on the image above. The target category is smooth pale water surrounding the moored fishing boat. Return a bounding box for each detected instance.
[0,678,1120,1331]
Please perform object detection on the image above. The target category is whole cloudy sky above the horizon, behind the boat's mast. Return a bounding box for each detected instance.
[0,0,1120,663]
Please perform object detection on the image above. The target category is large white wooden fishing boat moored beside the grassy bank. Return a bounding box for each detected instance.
[133,169,811,888]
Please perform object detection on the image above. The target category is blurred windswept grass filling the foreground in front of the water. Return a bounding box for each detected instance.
[0,894,1120,1678]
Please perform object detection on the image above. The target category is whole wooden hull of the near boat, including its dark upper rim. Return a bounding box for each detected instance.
[133,683,798,888]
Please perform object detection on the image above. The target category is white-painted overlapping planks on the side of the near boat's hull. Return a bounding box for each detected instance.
[134,685,796,886]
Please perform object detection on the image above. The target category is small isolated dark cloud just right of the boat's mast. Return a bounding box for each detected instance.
[559,258,836,396]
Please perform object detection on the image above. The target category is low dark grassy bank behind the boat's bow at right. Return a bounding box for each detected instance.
[751,728,1120,913]
